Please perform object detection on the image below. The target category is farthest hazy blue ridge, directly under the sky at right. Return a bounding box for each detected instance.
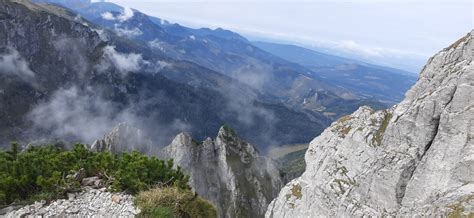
[253,42,416,104]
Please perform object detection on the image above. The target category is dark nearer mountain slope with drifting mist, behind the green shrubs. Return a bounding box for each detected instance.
[0,0,330,150]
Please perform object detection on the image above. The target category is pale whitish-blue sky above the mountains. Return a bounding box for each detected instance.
[98,0,474,73]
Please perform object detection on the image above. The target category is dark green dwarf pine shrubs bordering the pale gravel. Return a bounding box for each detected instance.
[0,143,190,205]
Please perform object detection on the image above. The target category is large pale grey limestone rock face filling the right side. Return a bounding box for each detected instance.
[266,32,474,217]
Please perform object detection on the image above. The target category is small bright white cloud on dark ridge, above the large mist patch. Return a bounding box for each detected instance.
[97,45,150,75]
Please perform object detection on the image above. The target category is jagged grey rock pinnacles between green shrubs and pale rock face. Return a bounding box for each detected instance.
[163,127,282,217]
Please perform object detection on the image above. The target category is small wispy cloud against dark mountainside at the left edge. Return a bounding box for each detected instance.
[0,47,35,80]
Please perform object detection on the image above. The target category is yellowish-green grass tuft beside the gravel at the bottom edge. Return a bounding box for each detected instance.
[135,187,217,218]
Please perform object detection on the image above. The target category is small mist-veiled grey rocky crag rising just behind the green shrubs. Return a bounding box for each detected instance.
[90,123,152,153]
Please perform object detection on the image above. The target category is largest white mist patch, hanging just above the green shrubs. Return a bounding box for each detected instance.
[28,87,136,143]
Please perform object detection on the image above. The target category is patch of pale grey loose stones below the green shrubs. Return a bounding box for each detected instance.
[5,188,140,218]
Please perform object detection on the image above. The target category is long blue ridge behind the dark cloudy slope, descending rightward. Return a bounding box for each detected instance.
[45,0,388,116]
